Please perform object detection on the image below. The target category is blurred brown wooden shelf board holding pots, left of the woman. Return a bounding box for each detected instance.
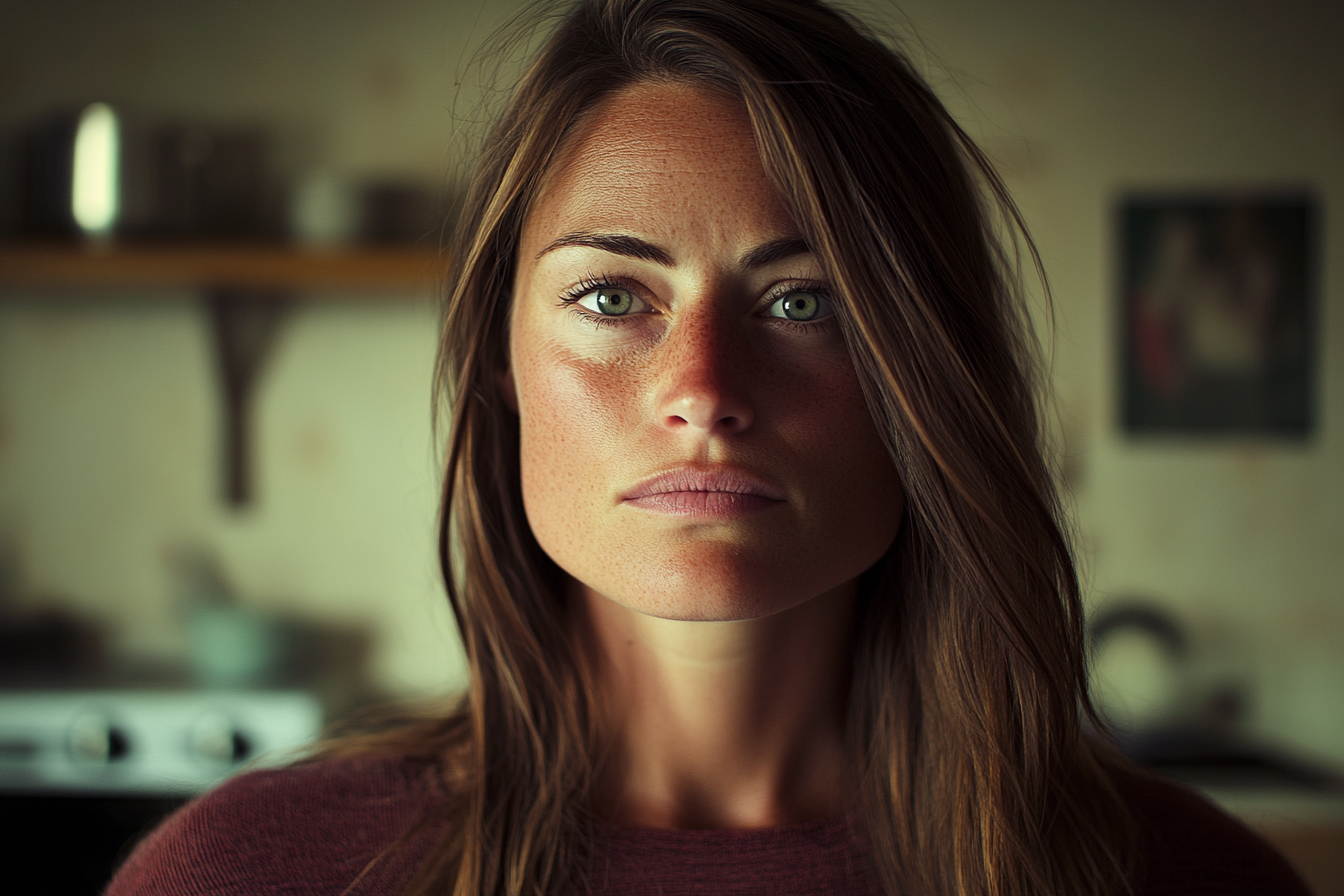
[0,243,445,293]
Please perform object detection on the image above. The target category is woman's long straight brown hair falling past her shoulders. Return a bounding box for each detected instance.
[387,0,1133,896]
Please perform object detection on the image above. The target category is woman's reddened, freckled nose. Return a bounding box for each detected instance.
[655,308,755,435]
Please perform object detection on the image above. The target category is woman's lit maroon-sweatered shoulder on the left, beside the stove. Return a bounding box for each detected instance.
[108,758,444,896]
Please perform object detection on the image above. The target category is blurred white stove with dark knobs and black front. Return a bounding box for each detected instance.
[0,689,323,896]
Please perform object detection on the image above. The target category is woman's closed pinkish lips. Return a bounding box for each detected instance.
[621,466,784,517]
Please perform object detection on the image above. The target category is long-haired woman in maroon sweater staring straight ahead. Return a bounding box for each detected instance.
[112,0,1304,896]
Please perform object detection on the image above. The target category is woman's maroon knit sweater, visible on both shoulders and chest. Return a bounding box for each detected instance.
[106,759,1308,896]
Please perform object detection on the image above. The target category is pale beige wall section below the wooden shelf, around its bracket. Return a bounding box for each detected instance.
[0,293,460,692]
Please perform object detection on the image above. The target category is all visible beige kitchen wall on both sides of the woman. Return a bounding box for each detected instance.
[0,0,1344,763]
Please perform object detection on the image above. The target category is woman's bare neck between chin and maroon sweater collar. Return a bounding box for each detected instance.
[575,583,855,829]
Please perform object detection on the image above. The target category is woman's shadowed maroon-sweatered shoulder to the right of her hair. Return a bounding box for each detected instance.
[1116,771,1308,896]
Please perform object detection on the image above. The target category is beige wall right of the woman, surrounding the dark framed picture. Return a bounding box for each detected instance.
[911,3,1344,760]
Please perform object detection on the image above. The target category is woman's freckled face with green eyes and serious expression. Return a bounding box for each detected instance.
[503,83,902,621]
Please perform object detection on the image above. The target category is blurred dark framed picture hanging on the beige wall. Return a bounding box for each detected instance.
[1120,193,1317,438]
